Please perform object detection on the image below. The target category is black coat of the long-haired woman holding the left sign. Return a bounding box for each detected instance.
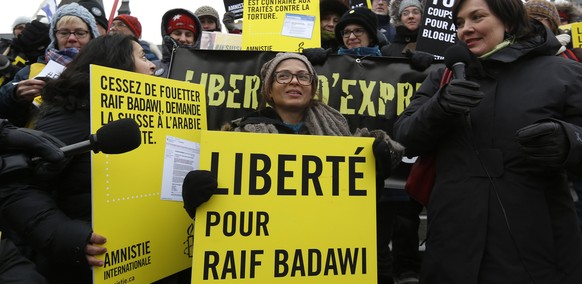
[0,95,92,284]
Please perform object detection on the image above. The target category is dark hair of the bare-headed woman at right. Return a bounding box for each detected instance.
[452,0,534,40]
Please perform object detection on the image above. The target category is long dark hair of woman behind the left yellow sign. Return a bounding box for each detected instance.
[42,34,139,110]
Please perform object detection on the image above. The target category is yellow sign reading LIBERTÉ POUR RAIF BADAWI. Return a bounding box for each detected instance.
[192,131,377,284]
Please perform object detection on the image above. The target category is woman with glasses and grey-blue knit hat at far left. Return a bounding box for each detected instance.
[0,3,99,126]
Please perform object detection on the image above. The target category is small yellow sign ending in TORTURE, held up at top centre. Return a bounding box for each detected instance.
[242,0,321,52]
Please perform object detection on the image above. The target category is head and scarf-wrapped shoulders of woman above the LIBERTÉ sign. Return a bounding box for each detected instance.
[223,53,342,136]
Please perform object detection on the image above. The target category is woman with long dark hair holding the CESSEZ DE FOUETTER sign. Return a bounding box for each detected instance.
[1,34,155,283]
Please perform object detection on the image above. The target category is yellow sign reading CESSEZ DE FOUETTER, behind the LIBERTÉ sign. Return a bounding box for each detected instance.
[91,65,207,284]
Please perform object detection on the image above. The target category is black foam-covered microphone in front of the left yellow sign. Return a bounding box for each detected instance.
[61,118,141,156]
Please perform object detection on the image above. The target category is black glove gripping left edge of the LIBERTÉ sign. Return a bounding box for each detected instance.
[182,170,218,218]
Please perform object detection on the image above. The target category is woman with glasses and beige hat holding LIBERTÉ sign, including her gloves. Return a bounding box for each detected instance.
[182,53,404,282]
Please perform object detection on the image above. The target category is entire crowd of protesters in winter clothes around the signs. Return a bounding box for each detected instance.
[0,0,582,284]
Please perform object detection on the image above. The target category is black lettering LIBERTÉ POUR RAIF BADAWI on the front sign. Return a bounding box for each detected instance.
[203,147,370,280]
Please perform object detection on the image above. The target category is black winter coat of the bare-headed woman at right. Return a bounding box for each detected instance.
[394,23,582,284]
